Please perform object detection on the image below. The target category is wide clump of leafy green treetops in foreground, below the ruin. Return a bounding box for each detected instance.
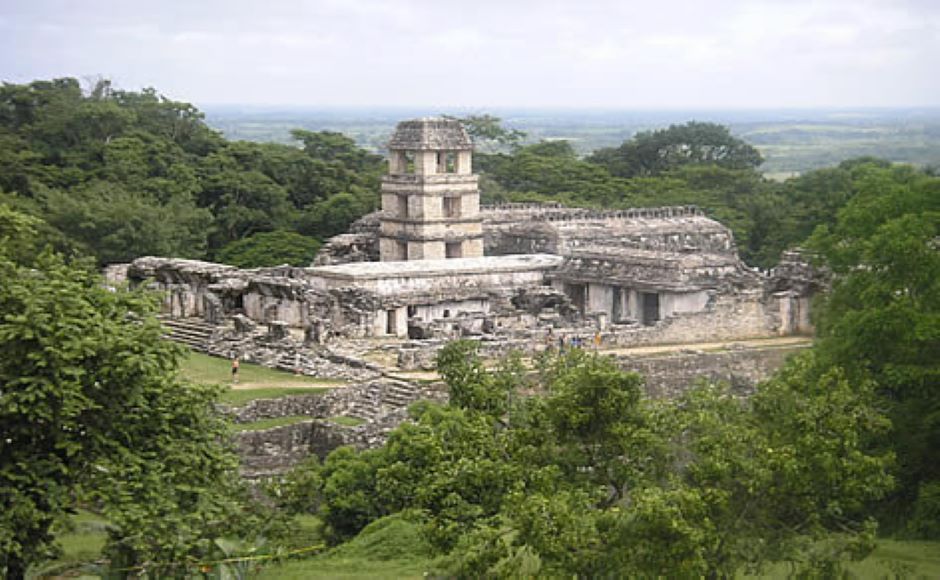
[282,342,892,577]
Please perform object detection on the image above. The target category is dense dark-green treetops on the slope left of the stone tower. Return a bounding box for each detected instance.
[0,79,384,265]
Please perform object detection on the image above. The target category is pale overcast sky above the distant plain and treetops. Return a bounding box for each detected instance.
[0,0,940,109]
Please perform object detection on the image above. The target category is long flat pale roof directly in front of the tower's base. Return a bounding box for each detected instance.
[307,254,564,280]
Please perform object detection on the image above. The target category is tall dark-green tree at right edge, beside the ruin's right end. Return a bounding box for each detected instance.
[809,163,940,524]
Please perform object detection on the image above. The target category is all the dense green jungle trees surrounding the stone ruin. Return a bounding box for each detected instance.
[0,79,940,578]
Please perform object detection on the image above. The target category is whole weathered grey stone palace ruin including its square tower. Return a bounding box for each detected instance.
[114,119,820,474]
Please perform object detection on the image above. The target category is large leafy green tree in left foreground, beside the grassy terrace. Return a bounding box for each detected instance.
[0,216,274,578]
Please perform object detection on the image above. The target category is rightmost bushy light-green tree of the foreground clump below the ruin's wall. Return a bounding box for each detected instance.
[607,357,892,577]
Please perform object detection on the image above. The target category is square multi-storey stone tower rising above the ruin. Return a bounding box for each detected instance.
[379,118,483,262]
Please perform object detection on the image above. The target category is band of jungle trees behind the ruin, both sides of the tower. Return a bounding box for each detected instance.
[0,78,932,268]
